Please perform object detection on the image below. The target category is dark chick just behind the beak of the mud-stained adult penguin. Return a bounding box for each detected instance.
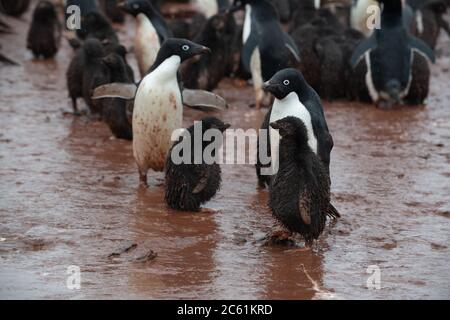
[181,14,236,91]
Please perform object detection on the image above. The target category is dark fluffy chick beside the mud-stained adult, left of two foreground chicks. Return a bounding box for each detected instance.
[165,117,230,212]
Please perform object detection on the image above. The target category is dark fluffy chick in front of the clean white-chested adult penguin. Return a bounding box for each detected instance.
[269,117,340,246]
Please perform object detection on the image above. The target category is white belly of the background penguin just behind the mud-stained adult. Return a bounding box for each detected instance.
[135,13,161,75]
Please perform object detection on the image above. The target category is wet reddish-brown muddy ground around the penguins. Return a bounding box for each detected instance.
[0,7,450,299]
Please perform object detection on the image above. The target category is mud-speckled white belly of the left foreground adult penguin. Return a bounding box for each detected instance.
[133,75,183,171]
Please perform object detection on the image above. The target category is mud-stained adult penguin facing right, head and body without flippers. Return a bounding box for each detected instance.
[133,38,210,185]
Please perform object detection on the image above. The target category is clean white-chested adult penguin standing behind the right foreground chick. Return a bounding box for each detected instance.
[256,69,333,187]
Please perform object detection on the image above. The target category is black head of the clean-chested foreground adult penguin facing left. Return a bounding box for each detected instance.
[263,68,306,100]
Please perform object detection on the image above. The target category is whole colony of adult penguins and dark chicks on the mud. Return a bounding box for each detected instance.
[6,0,450,246]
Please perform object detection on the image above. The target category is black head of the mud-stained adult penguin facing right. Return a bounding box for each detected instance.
[157,38,211,62]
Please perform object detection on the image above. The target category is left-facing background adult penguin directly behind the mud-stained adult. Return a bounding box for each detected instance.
[119,0,172,77]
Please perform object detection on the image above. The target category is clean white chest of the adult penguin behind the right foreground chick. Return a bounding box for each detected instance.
[269,92,317,159]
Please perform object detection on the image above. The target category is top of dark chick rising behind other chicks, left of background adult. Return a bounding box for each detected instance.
[77,11,119,43]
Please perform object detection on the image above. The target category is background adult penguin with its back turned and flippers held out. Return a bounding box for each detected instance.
[351,0,435,107]
